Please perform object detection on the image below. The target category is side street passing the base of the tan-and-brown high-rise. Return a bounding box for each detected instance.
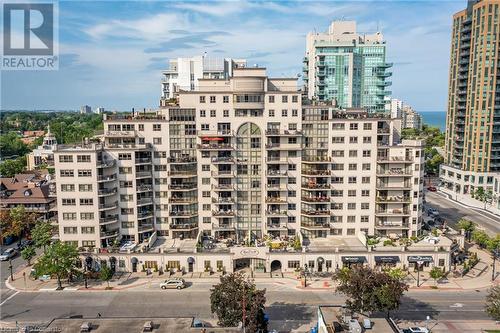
[425,191,500,236]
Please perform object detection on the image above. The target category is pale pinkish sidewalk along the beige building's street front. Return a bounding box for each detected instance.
[6,247,500,292]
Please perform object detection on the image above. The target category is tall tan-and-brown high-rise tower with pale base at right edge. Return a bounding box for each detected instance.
[441,0,500,208]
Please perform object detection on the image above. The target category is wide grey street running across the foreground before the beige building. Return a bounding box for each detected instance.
[0,280,488,331]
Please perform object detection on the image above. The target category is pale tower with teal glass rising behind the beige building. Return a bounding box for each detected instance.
[303,21,392,113]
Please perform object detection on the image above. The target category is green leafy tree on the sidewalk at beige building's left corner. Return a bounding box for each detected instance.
[35,241,78,289]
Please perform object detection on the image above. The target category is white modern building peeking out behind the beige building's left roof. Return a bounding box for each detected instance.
[160,54,246,105]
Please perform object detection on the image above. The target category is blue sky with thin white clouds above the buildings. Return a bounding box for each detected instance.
[0,0,466,112]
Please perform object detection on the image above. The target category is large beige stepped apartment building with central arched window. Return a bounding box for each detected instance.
[54,68,450,271]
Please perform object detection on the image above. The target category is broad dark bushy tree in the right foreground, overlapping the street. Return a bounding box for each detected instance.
[334,267,408,315]
